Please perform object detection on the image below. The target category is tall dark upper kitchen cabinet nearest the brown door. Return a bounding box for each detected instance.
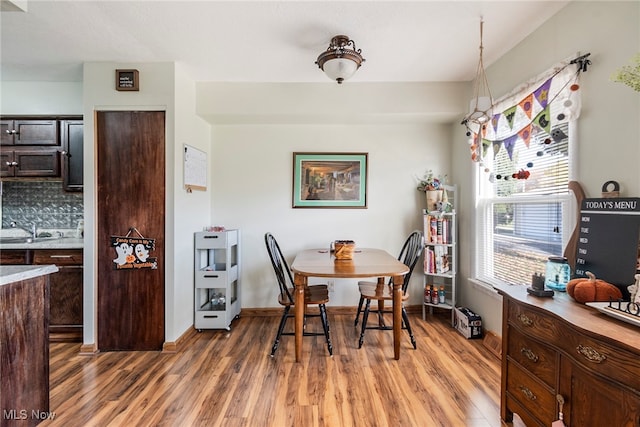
[60,120,84,191]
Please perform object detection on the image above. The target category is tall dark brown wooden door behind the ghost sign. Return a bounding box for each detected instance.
[97,111,165,351]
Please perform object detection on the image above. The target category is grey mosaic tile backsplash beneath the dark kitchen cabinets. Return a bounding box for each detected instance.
[1,181,84,229]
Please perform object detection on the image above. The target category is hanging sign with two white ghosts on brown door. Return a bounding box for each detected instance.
[111,227,158,270]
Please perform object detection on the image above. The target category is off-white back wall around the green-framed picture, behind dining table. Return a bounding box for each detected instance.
[212,124,451,307]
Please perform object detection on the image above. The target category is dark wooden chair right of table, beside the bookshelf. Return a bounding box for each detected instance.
[354,231,424,349]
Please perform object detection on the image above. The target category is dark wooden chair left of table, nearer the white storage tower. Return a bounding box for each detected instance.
[264,233,333,357]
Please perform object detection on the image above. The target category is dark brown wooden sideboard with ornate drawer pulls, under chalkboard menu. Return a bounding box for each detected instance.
[496,286,640,427]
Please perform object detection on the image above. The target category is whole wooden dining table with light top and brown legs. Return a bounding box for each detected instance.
[291,248,409,362]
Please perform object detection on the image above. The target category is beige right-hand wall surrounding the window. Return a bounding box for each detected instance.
[452,2,640,334]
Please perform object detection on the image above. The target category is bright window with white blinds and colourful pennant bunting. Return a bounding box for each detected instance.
[472,59,579,285]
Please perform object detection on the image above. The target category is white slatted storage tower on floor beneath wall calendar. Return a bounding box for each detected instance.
[194,230,241,331]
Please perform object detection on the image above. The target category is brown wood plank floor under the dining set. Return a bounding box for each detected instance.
[40,308,520,427]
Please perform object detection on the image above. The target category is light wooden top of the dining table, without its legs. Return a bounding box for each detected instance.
[291,248,409,278]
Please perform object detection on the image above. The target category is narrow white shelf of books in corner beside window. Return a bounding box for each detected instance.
[422,185,458,325]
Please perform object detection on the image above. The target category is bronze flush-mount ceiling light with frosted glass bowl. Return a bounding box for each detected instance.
[316,36,365,84]
